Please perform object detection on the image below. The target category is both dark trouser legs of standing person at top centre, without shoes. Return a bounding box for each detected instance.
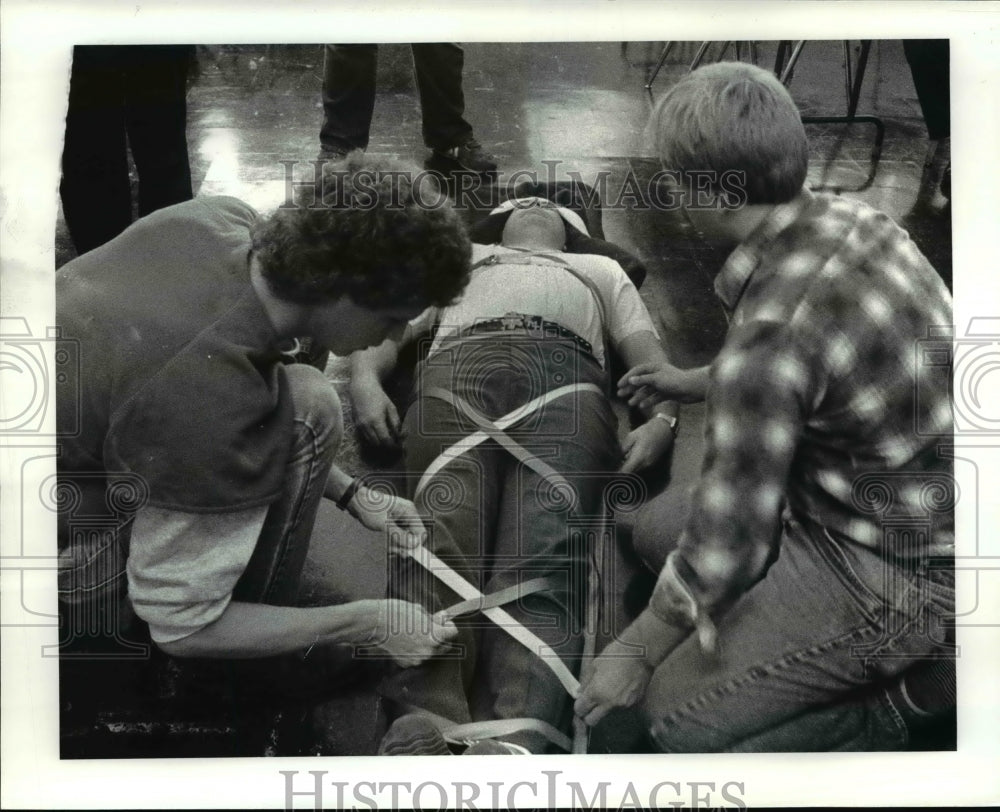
[319,42,472,150]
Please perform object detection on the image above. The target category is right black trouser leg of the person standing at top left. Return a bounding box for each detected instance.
[124,45,194,217]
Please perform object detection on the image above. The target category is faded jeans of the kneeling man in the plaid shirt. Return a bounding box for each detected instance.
[635,410,954,753]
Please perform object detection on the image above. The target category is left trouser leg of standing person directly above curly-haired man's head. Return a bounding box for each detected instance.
[319,45,378,156]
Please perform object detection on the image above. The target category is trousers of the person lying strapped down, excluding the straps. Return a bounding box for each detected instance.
[382,334,621,752]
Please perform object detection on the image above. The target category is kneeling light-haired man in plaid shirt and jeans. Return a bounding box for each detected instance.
[576,63,954,752]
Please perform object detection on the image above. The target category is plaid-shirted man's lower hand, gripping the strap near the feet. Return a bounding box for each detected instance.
[573,640,653,726]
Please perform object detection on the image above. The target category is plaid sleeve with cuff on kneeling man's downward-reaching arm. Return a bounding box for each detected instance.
[650,323,819,649]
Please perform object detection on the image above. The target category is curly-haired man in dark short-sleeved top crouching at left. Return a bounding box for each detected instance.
[56,156,469,692]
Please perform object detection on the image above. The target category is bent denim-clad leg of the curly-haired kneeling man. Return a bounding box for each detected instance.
[234,364,344,606]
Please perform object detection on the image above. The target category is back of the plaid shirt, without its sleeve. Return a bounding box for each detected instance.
[715,190,954,557]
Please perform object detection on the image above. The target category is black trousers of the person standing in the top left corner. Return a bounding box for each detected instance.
[59,45,192,254]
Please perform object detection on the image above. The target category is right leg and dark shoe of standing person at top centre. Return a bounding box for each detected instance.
[411,42,497,173]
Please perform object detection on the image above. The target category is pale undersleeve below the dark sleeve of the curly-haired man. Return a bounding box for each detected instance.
[127,505,268,643]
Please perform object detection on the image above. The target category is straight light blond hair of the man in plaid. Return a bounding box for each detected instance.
[649,62,809,204]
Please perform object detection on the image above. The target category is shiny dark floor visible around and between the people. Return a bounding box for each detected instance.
[56,41,951,755]
